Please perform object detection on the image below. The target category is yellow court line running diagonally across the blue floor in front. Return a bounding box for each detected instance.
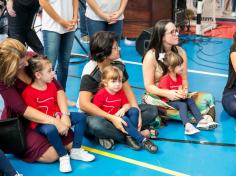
[82,146,189,176]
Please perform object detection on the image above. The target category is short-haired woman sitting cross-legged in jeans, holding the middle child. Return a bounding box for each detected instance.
[78,31,158,149]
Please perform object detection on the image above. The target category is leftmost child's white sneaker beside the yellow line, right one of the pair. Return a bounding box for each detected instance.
[70,148,95,162]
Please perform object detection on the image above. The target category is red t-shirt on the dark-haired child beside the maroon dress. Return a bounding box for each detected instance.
[22,82,60,129]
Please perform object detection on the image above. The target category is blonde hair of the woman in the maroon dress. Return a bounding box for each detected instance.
[0,38,26,86]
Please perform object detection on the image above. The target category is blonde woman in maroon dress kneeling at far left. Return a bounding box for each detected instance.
[0,38,73,162]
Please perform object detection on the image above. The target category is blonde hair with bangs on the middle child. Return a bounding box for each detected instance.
[100,66,123,87]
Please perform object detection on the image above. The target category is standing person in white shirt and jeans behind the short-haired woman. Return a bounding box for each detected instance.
[85,0,128,43]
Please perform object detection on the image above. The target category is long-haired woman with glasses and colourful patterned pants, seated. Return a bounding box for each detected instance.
[143,20,215,121]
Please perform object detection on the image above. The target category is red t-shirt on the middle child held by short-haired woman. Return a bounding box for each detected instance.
[93,88,129,114]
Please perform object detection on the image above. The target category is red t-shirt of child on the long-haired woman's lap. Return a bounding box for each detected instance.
[158,74,183,102]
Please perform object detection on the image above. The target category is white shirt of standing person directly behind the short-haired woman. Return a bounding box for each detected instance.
[85,0,124,21]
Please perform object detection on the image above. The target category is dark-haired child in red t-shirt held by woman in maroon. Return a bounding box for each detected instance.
[22,56,95,172]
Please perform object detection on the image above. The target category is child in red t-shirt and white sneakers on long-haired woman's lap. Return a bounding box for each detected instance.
[158,52,217,135]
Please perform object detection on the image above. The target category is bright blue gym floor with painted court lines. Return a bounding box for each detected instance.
[0,31,236,176]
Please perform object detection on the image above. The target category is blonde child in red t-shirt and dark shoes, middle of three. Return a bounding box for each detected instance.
[93,66,158,153]
